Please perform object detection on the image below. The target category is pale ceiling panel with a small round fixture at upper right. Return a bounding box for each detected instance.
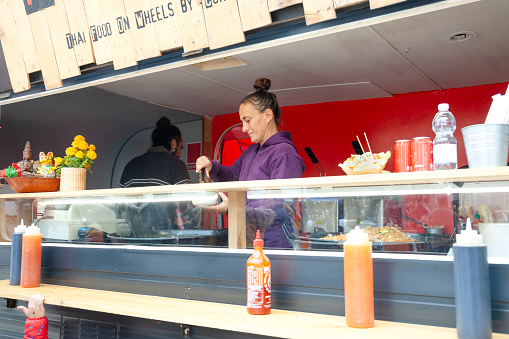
[373,0,509,88]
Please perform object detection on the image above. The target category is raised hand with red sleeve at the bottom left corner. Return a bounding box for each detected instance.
[17,294,48,339]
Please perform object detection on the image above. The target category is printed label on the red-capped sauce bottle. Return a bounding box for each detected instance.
[247,265,271,308]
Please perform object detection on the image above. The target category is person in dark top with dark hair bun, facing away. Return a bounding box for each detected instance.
[119,117,191,237]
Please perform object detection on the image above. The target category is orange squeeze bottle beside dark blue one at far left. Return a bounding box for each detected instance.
[20,223,42,287]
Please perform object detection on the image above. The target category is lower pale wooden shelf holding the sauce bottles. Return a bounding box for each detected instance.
[0,280,509,339]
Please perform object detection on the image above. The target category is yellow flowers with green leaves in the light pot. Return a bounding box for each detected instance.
[55,135,97,174]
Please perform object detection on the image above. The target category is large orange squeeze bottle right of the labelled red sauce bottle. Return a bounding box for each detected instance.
[343,226,375,328]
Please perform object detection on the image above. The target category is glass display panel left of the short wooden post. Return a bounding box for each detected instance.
[33,192,224,246]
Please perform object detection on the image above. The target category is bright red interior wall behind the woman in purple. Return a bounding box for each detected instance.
[212,83,507,177]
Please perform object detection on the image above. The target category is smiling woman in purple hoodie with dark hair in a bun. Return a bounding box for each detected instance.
[196,78,304,248]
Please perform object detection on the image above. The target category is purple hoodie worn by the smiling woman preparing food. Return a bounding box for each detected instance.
[209,131,304,248]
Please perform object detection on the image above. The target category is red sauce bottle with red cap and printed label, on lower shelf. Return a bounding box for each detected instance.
[246,230,271,315]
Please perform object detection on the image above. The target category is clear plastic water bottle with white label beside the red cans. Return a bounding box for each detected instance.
[433,104,458,171]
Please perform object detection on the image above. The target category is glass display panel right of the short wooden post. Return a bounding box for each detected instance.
[247,182,509,257]
